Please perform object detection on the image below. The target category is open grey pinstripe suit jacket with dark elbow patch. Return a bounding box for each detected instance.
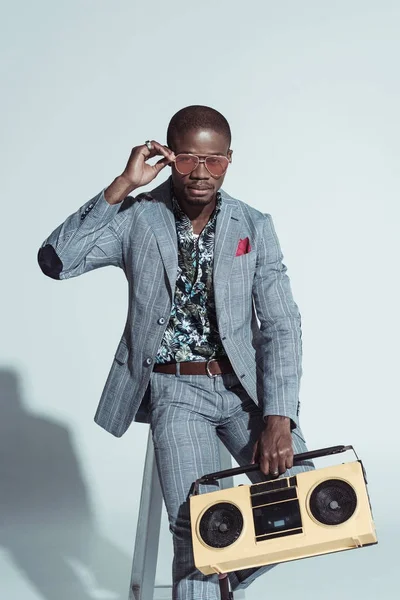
[38,179,302,437]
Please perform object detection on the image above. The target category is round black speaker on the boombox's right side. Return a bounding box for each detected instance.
[310,479,357,525]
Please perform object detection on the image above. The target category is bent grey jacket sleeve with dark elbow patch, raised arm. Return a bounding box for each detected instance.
[38,189,123,279]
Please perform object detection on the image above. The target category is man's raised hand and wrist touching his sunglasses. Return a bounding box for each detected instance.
[104,140,175,204]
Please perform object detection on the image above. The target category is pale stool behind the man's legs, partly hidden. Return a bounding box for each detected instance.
[129,430,245,600]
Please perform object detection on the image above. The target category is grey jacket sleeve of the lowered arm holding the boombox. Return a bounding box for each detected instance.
[253,214,302,429]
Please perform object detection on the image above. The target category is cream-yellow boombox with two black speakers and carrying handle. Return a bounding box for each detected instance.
[190,446,377,575]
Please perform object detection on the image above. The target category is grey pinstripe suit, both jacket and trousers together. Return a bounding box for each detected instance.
[38,180,313,600]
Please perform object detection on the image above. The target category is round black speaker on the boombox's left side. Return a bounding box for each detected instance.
[199,502,243,548]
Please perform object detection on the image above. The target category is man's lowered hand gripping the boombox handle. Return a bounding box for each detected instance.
[251,415,293,476]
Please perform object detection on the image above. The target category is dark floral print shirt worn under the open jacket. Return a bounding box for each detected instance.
[156,192,226,363]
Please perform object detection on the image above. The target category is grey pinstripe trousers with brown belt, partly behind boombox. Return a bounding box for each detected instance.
[149,372,314,600]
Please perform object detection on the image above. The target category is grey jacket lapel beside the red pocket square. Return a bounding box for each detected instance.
[213,190,241,315]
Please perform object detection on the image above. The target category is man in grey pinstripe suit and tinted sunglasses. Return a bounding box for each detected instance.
[38,106,313,600]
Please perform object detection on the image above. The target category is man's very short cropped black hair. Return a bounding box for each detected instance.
[167,104,232,148]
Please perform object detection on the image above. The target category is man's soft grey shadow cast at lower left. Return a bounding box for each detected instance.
[0,369,132,600]
